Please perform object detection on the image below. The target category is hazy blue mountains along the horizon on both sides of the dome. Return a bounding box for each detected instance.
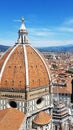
[0,45,73,53]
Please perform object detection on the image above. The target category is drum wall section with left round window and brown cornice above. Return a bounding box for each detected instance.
[0,92,25,112]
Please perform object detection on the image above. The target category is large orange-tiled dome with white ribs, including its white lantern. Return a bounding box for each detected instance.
[0,19,50,91]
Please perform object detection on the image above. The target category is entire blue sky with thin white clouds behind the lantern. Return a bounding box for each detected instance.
[0,0,73,47]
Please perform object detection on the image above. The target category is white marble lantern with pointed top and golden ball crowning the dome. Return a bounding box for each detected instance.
[18,17,28,44]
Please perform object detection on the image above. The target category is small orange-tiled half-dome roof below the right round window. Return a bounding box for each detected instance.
[33,111,52,125]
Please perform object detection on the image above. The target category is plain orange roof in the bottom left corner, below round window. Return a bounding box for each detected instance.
[0,108,25,130]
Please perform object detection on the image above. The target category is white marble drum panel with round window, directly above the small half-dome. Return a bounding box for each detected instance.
[27,94,52,116]
